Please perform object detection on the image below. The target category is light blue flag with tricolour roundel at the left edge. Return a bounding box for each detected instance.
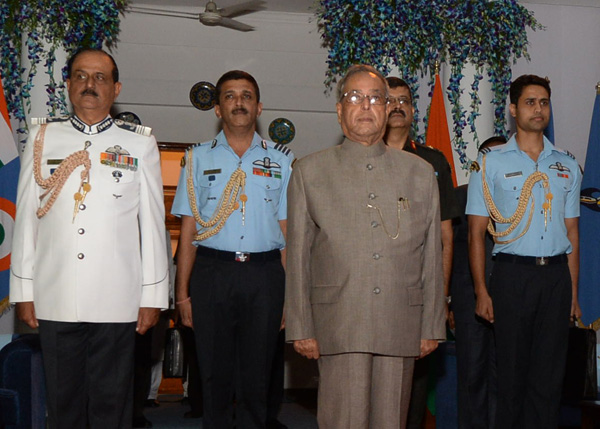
[0,79,19,316]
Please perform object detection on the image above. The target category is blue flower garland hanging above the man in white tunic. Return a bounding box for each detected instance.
[0,0,128,135]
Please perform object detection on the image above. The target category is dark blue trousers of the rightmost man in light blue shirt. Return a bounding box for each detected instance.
[489,260,572,429]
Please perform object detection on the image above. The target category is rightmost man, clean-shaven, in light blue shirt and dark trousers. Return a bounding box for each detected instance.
[467,75,581,429]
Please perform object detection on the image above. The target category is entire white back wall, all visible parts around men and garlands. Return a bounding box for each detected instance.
[115,3,600,183]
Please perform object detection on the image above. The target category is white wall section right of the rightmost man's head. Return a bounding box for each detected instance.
[513,4,600,166]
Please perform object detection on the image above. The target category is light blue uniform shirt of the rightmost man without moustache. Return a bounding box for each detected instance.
[466,136,581,256]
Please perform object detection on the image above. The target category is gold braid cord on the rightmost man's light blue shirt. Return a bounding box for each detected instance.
[481,155,552,244]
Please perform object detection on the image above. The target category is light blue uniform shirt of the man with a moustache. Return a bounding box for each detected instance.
[171,131,294,252]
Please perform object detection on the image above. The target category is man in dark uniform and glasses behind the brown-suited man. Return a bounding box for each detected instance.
[384,77,460,429]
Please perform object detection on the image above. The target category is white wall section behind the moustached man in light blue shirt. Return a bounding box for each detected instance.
[115,12,341,156]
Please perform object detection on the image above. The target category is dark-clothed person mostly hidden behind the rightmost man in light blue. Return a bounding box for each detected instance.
[450,137,506,429]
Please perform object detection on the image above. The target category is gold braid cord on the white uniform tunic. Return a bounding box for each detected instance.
[33,124,92,219]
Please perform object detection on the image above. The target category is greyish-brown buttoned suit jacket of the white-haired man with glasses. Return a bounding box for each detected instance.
[285,139,445,356]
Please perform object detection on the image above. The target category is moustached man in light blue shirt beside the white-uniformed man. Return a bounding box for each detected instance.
[172,70,293,429]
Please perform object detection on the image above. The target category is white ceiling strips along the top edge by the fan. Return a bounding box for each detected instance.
[131,0,600,13]
